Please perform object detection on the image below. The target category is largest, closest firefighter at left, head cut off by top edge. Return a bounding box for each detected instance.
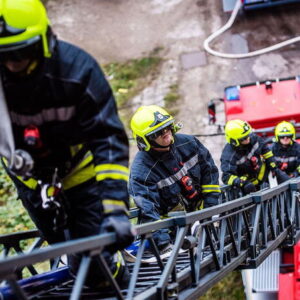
[0,0,133,285]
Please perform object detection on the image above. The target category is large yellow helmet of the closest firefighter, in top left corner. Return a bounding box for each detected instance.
[0,0,53,59]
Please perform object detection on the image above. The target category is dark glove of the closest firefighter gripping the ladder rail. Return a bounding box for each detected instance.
[100,212,135,252]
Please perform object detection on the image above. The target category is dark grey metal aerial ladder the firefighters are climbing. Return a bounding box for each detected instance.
[0,179,300,300]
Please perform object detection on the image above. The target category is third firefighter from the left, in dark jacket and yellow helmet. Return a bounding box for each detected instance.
[221,120,289,194]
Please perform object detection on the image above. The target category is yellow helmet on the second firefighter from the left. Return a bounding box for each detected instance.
[130,105,174,151]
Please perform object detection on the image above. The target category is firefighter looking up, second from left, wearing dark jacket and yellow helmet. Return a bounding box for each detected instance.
[129,105,220,249]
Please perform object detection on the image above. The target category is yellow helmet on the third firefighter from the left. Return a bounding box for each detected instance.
[225,120,252,147]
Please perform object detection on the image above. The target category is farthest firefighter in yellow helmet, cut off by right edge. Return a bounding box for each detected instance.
[272,121,300,177]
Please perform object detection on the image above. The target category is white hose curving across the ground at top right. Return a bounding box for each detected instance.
[203,0,300,58]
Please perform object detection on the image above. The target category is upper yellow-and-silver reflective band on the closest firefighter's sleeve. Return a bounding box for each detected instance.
[95,164,129,181]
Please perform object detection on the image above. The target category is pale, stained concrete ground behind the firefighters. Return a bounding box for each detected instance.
[47,0,300,169]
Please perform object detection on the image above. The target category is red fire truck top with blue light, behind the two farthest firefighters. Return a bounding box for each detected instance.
[224,76,300,134]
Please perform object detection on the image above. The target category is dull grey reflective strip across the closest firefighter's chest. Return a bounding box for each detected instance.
[10,106,75,126]
